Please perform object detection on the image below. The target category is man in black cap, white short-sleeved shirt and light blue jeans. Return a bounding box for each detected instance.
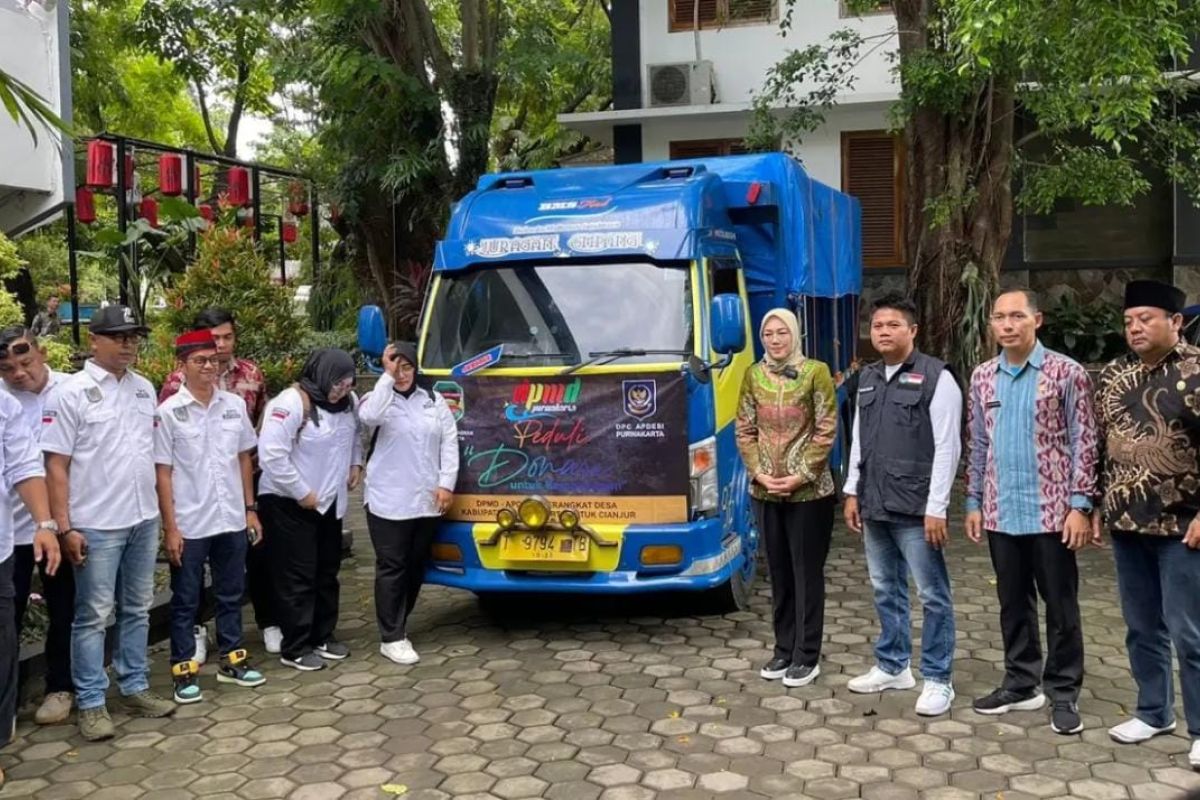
[41,305,175,741]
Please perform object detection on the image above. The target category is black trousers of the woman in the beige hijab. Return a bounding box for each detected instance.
[755,497,834,667]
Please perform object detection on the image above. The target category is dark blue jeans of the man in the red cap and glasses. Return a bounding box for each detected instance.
[170,530,248,664]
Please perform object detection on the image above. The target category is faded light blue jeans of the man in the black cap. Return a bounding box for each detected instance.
[71,517,158,710]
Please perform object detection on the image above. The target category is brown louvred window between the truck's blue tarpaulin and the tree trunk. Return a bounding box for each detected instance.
[841,131,905,266]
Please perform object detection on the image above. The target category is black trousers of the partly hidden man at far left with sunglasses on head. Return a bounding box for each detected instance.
[12,545,74,693]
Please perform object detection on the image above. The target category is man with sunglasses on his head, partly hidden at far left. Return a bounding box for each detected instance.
[0,325,74,724]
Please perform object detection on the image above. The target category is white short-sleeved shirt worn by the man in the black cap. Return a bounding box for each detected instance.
[41,359,158,530]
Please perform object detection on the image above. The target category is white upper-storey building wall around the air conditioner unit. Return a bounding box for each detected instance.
[641,0,898,106]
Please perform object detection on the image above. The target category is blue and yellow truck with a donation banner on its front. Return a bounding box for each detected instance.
[365,154,862,608]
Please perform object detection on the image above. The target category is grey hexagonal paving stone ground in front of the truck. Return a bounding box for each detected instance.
[0,496,1200,800]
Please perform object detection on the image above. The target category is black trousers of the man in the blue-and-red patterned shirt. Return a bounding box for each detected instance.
[988,533,1084,702]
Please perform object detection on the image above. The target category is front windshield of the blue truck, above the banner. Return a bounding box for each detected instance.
[424,263,692,369]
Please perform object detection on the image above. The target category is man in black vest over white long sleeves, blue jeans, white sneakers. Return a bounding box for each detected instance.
[845,295,962,716]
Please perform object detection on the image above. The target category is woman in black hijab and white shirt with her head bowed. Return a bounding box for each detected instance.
[258,348,362,672]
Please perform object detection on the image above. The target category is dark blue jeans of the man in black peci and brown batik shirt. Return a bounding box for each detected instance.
[1112,531,1200,739]
